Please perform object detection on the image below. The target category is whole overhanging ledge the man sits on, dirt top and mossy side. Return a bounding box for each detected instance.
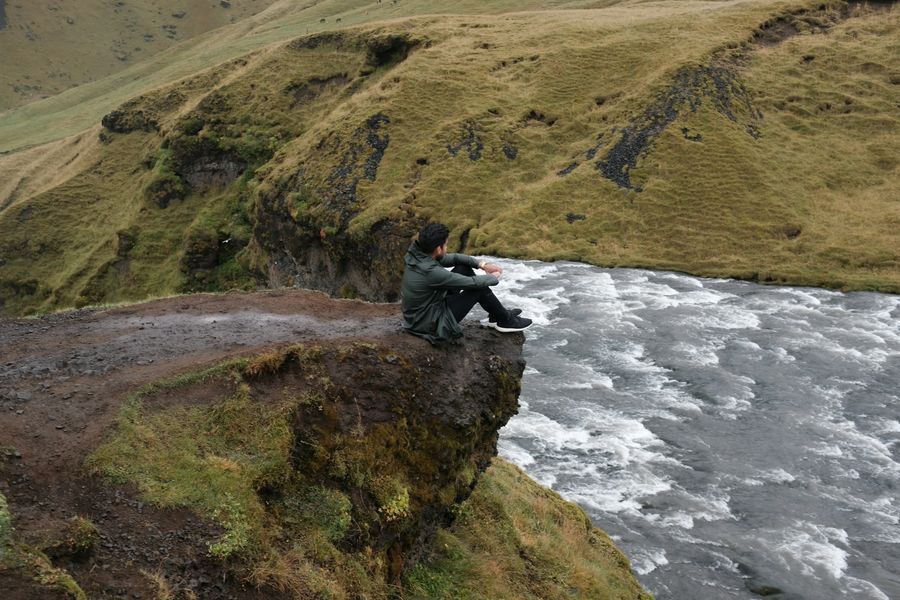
[0,291,524,599]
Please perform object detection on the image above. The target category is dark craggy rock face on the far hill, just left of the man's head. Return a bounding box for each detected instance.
[252,113,418,301]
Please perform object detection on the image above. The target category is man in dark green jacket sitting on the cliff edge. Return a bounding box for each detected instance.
[400,223,531,344]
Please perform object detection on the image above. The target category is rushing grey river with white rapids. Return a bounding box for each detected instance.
[482,260,900,600]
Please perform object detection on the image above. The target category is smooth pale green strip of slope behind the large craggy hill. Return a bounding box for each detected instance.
[0,0,624,154]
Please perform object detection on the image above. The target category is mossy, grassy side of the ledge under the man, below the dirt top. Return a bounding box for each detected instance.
[88,328,524,597]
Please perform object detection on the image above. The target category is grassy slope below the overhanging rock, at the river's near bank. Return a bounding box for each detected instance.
[404,458,651,600]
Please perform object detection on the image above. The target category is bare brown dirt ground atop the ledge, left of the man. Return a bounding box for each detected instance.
[0,290,408,600]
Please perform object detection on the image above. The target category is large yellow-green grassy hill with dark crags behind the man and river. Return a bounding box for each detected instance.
[0,0,900,314]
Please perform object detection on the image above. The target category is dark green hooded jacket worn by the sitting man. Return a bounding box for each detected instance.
[400,242,500,344]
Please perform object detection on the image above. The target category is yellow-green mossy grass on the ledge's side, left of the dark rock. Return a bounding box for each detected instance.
[88,346,398,598]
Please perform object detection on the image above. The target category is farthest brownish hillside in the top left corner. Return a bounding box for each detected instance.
[0,0,282,111]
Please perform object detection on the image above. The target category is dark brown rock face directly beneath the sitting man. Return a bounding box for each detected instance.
[270,329,524,581]
